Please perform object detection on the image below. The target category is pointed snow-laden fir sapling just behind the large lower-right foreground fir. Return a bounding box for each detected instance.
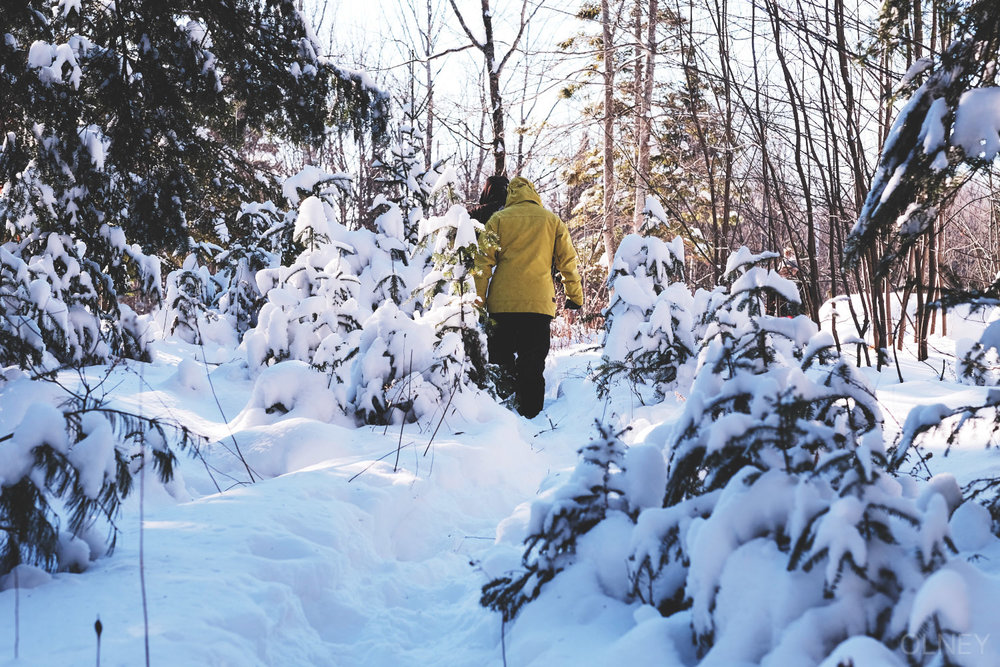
[665,248,816,505]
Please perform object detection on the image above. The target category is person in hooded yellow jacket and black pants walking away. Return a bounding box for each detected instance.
[475,177,583,419]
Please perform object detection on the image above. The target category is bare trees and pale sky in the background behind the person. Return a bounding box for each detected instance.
[296,0,1000,363]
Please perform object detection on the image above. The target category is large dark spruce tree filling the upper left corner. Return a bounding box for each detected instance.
[0,0,386,365]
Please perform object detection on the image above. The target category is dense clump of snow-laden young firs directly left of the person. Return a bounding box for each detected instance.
[243,196,485,423]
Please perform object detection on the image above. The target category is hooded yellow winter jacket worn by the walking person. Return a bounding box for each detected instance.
[475,177,583,317]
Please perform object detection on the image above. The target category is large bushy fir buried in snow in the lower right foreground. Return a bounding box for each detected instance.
[629,342,958,665]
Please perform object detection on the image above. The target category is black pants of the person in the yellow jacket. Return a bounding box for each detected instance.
[488,313,552,419]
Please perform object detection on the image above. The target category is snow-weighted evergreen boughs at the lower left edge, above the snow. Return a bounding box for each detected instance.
[0,388,201,574]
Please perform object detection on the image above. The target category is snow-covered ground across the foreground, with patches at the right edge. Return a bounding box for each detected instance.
[0,316,1000,666]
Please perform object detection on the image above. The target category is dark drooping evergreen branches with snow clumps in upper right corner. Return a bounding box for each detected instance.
[845,0,1000,290]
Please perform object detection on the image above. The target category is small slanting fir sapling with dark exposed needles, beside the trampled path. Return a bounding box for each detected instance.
[480,422,633,622]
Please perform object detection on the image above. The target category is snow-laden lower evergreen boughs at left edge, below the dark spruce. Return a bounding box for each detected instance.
[0,227,160,367]
